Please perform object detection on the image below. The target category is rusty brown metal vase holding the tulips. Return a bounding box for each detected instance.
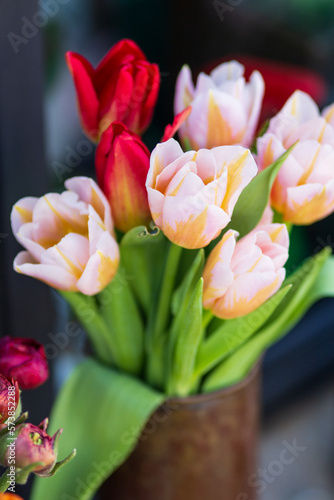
[101,366,260,500]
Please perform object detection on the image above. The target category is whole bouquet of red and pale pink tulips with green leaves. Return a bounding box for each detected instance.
[5,40,334,500]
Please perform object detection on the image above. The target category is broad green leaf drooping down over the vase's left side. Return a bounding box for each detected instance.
[31,359,164,500]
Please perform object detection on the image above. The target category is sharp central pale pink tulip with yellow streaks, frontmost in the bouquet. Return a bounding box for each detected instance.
[146,139,257,248]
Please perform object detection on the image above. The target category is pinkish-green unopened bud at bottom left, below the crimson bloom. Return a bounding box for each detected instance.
[0,419,75,484]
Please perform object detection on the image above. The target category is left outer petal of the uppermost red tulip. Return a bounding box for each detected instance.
[66,52,99,140]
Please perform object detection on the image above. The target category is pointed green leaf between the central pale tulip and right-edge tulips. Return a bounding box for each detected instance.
[224,145,295,238]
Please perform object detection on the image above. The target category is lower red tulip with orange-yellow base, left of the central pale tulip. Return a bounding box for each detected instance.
[95,122,152,232]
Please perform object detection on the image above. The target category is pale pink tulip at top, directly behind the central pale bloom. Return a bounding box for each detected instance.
[174,61,264,149]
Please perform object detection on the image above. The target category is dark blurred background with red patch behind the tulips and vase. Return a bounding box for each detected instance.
[0,0,334,500]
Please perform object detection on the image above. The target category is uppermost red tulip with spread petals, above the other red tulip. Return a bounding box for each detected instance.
[66,40,160,141]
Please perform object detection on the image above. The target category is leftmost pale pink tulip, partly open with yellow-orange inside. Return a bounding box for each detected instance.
[11,177,119,295]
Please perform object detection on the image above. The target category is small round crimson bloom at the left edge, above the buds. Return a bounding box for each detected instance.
[0,337,49,389]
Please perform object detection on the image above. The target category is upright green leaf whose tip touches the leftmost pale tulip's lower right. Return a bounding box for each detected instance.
[98,265,144,375]
